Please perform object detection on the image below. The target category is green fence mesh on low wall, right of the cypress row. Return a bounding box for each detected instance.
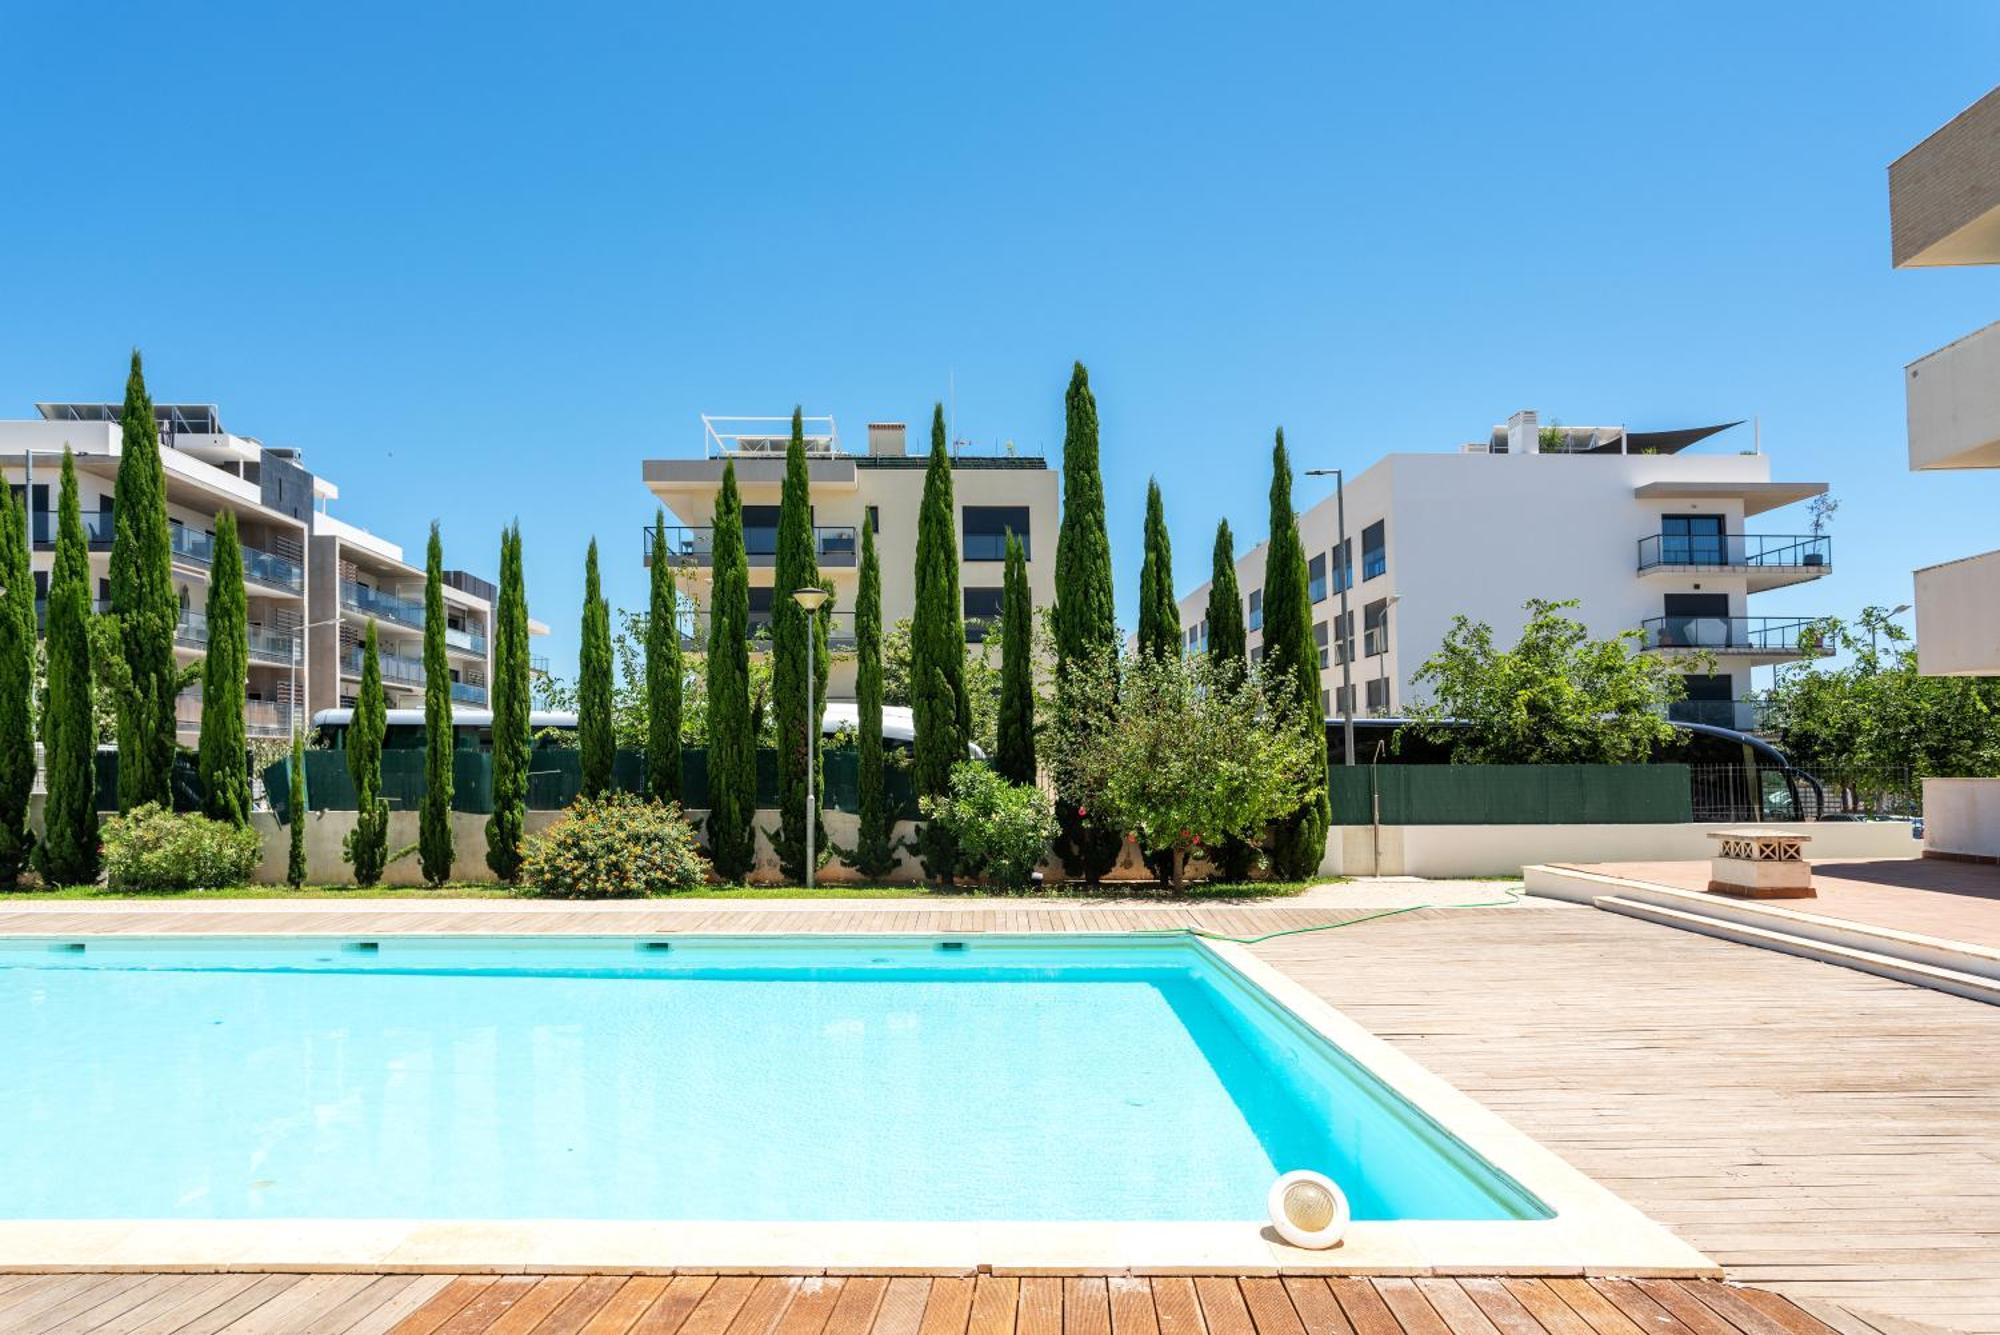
[1332,765,1694,825]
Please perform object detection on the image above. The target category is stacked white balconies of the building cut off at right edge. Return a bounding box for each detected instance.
[1888,88,2000,861]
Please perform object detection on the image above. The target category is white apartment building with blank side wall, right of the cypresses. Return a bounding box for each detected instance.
[1180,412,1832,727]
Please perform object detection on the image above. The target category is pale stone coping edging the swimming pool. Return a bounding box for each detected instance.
[0,931,1722,1279]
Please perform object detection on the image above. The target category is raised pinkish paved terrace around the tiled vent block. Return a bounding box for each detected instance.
[1564,845,2000,949]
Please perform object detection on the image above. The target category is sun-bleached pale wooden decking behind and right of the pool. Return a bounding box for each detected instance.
[0,885,2000,1335]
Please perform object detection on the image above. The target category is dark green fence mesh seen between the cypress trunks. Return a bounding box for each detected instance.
[262,747,916,821]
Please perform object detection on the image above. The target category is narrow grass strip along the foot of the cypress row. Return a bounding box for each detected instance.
[0,877,1344,903]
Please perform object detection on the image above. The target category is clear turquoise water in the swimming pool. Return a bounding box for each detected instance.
[0,937,1546,1221]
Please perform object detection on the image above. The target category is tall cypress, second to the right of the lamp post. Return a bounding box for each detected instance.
[910,404,972,883]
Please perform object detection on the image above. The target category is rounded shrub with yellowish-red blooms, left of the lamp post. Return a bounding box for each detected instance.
[520,793,708,899]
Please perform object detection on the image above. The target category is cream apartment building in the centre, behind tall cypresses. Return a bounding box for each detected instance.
[642,418,1060,699]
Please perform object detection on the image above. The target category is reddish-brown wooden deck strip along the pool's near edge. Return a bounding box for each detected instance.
[0,1275,1856,1335]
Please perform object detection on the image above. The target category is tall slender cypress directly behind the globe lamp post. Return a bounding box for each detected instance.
[770,408,830,881]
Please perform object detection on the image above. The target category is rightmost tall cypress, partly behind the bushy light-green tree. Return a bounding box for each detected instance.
[1264,428,1332,879]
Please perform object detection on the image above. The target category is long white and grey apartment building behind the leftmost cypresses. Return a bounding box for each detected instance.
[0,404,508,743]
